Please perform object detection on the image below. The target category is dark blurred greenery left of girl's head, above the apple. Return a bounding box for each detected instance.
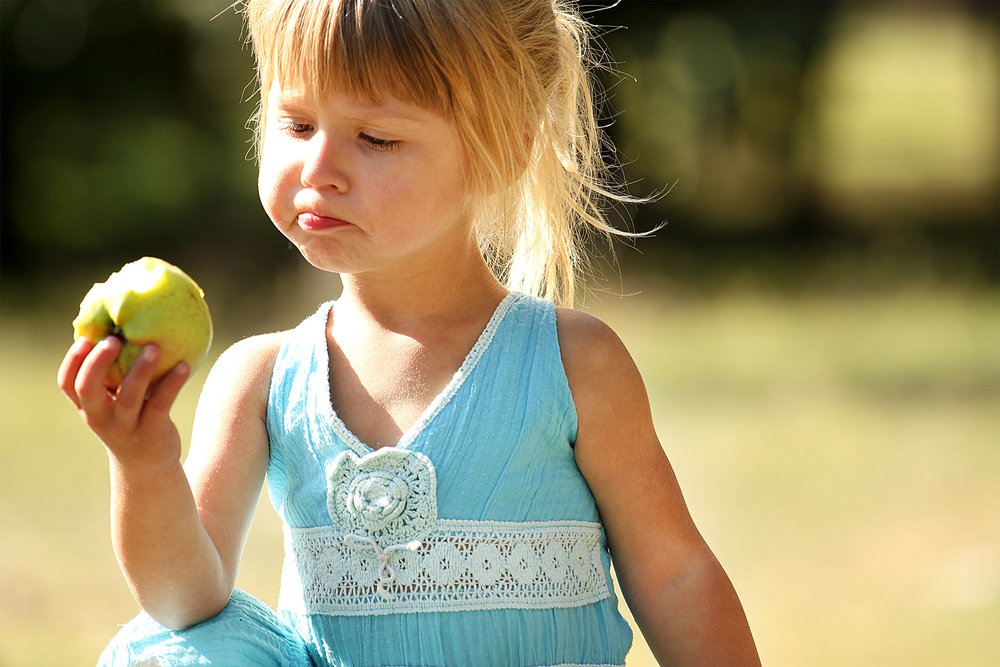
[0,0,271,270]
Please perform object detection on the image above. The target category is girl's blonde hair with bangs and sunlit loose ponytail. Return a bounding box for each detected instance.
[243,0,636,304]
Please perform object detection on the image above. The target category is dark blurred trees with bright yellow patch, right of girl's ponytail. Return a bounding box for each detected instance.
[594,1,1000,280]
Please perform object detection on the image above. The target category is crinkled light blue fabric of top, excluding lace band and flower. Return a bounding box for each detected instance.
[268,293,632,665]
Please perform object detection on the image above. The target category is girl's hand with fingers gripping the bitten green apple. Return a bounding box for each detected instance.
[58,336,190,470]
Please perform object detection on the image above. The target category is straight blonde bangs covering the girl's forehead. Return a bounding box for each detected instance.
[246,0,453,117]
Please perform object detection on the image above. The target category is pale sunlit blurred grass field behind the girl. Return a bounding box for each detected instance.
[0,280,1000,667]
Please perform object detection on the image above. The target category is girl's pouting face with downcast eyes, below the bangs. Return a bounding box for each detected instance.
[258,85,475,282]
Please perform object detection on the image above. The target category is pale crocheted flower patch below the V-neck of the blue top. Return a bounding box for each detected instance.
[327,448,437,548]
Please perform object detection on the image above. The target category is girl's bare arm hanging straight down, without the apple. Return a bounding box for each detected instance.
[559,310,760,665]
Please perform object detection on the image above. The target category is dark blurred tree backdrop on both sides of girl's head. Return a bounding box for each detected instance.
[0,0,1000,290]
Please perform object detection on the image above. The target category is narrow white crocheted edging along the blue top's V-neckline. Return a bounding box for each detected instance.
[313,292,521,456]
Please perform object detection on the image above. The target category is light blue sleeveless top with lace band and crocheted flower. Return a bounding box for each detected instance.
[101,294,632,666]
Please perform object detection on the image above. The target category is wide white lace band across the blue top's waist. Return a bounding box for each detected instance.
[278,520,610,616]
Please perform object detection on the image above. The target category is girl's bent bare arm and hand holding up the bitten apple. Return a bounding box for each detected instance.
[58,338,276,629]
